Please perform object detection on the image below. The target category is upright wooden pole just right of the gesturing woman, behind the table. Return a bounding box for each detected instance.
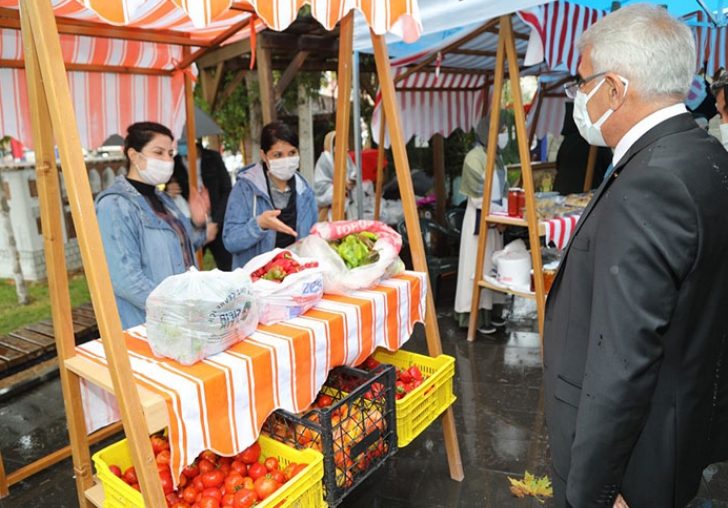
[331,11,354,220]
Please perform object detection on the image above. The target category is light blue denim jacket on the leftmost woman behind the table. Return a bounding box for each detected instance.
[96,176,206,329]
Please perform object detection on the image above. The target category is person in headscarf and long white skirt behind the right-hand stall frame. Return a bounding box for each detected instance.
[455,114,508,334]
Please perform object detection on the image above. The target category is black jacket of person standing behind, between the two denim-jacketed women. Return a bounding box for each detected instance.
[173,148,233,225]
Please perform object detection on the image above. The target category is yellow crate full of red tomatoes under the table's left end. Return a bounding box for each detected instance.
[93,433,325,508]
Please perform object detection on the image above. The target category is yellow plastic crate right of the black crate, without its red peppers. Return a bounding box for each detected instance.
[372,348,457,448]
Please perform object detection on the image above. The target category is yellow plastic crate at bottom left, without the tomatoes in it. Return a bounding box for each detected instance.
[93,436,326,508]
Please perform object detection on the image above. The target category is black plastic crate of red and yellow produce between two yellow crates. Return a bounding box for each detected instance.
[262,364,397,506]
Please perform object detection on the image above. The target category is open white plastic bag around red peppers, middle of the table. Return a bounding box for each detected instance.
[243,249,324,325]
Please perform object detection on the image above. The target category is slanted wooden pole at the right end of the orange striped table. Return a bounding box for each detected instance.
[370,28,465,481]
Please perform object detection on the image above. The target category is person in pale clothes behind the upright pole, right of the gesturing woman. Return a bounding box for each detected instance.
[313,131,356,222]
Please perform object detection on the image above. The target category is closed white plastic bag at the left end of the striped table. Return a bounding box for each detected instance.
[146,268,258,365]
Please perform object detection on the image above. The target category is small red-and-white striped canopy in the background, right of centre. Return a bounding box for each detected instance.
[372,67,485,147]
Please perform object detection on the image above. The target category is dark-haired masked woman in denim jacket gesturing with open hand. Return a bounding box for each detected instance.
[222,122,317,269]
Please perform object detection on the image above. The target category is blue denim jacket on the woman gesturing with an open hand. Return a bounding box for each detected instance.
[222,163,318,270]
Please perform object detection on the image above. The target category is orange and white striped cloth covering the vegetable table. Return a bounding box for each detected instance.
[76,272,426,486]
